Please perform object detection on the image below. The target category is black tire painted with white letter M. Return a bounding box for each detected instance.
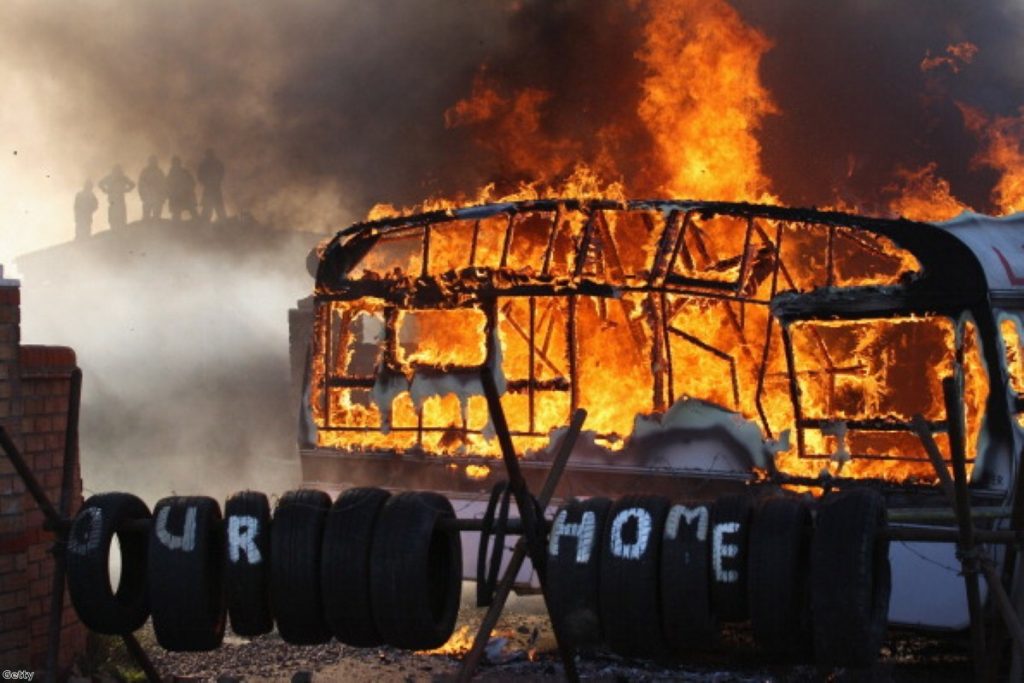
[659,504,718,656]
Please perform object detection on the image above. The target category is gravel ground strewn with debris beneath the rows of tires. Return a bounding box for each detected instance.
[79,590,972,683]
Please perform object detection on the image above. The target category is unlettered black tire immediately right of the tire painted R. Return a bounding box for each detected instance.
[270,488,331,645]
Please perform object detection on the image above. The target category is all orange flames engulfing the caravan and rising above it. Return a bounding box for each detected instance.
[310,6,1024,485]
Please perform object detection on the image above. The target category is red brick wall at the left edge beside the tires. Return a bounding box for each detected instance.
[0,270,85,672]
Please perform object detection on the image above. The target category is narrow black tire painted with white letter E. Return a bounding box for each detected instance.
[709,495,754,622]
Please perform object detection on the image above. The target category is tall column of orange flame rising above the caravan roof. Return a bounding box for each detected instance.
[637,0,776,202]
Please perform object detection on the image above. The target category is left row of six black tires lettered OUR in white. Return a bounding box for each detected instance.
[67,488,462,651]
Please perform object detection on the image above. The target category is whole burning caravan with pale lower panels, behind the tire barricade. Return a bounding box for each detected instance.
[292,200,1024,628]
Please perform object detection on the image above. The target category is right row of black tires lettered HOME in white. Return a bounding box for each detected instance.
[547,489,891,668]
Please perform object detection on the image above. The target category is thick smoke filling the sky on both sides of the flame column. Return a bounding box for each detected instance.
[0,0,1024,239]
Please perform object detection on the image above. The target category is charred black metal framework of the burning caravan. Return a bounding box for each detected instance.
[307,200,1019,485]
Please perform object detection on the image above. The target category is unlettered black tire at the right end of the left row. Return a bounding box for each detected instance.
[370,492,462,650]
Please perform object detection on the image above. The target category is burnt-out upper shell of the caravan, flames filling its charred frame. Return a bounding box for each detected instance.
[299,200,1020,491]
